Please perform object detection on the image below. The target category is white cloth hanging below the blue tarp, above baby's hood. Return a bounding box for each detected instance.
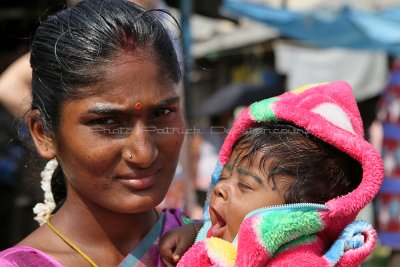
[273,41,388,102]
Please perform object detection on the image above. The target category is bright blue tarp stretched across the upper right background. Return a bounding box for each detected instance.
[223,0,400,55]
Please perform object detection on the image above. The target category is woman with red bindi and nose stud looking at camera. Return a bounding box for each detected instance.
[0,0,190,266]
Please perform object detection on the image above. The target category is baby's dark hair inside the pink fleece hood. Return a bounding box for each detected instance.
[233,122,362,204]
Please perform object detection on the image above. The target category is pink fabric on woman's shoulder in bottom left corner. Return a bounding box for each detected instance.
[0,245,63,267]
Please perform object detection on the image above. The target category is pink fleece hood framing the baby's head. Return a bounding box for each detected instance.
[204,81,383,240]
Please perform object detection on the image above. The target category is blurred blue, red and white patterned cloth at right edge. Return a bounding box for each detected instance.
[370,58,400,267]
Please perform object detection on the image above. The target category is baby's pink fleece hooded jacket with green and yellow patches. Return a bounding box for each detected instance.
[178,81,383,267]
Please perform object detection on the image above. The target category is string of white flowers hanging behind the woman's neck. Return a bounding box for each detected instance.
[33,158,58,225]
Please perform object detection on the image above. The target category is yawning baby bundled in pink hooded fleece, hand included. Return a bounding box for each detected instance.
[161,82,383,266]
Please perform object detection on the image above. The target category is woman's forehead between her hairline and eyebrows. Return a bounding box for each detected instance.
[61,53,180,113]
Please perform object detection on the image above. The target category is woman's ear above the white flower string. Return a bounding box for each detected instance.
[28,110,56,160]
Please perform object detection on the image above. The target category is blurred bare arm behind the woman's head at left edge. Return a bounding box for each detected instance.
[0,53,32,118]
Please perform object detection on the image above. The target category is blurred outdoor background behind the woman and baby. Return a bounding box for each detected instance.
[0,0,400,266]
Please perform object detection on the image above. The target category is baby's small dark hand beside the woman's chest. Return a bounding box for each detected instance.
[160,222,203,267]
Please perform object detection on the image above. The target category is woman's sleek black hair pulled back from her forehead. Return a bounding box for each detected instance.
[30,0,181,211]
